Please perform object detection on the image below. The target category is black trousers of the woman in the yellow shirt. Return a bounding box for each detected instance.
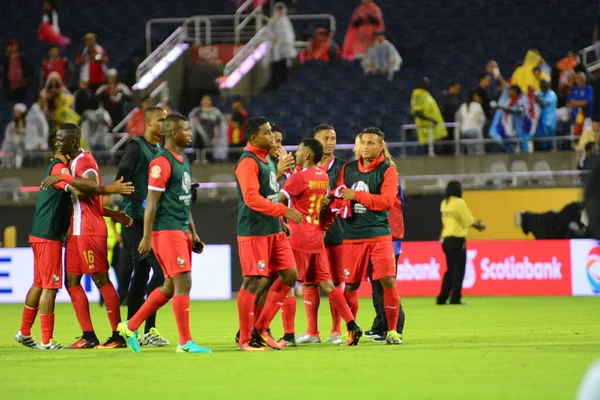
[437,237,467,304]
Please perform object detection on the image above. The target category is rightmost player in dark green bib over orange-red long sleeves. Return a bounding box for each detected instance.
[337,128,402,344]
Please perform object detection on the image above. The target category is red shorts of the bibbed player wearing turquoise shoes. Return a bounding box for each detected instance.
[152,230,192,278]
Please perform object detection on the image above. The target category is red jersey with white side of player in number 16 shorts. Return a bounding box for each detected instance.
[71,151,108,237]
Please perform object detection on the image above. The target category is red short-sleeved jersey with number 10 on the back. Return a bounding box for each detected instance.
[281,168,329,253]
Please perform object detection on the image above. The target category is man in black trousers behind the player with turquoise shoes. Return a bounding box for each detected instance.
[117,107,169,347]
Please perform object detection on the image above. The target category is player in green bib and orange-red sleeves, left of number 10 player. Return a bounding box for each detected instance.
[235,117,302,351]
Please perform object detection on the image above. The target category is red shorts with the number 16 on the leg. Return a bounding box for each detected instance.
[65,236,108,275]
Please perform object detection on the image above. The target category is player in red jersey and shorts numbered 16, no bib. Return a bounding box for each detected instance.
[43,124,133,349]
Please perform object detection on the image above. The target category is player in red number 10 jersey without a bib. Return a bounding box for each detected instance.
[278,138,362,346]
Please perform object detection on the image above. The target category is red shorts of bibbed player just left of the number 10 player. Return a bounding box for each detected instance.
[238,232,296,277]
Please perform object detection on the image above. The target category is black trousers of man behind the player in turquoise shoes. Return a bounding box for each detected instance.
[123,220,165,333]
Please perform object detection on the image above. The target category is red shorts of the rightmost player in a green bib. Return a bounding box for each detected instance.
[344,240,396,283]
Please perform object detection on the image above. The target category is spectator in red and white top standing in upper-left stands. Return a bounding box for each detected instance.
[75,33,108,91]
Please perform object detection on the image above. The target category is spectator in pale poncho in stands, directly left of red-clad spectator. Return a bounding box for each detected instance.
[188,95,225,164]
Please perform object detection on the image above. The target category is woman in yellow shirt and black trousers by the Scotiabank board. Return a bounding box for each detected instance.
[436,181,485,304]
